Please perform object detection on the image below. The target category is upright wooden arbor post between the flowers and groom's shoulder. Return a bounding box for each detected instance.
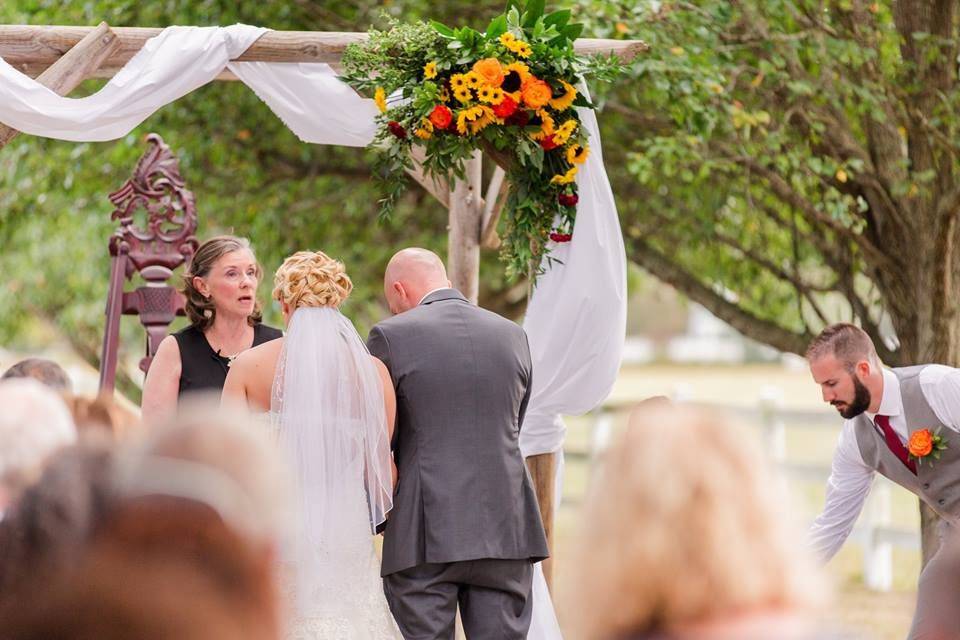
[447,151,483,304]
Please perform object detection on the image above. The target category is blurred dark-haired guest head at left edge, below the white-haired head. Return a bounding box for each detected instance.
[0,437,113,602]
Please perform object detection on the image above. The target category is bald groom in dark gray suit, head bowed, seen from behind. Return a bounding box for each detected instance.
[367,249,548,640]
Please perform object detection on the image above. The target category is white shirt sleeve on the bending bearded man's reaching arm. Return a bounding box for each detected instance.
[809,421,874,562]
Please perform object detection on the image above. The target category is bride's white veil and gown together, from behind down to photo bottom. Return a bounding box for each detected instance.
[269,308,401,640]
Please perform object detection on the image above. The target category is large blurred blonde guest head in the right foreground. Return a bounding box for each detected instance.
[574,405,823,640]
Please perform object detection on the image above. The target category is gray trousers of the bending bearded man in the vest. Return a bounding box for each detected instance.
[908,520,960,640]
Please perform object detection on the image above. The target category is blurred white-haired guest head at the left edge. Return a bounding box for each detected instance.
[0,378,77,509]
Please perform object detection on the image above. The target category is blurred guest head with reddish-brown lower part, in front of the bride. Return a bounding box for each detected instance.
[96,401,286,637]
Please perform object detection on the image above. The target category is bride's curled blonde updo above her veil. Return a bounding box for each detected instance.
[273,251,353,311]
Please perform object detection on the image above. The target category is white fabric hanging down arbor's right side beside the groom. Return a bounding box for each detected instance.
[520,95,627,456]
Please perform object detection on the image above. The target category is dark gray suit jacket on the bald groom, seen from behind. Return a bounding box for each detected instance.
[367,289,548,576]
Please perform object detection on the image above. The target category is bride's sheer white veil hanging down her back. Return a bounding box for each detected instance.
[271,307,393,606]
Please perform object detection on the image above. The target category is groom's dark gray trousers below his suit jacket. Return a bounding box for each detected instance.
[383,559,533,640]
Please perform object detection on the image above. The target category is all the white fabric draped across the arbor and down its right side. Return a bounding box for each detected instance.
[0,24,626,640]
